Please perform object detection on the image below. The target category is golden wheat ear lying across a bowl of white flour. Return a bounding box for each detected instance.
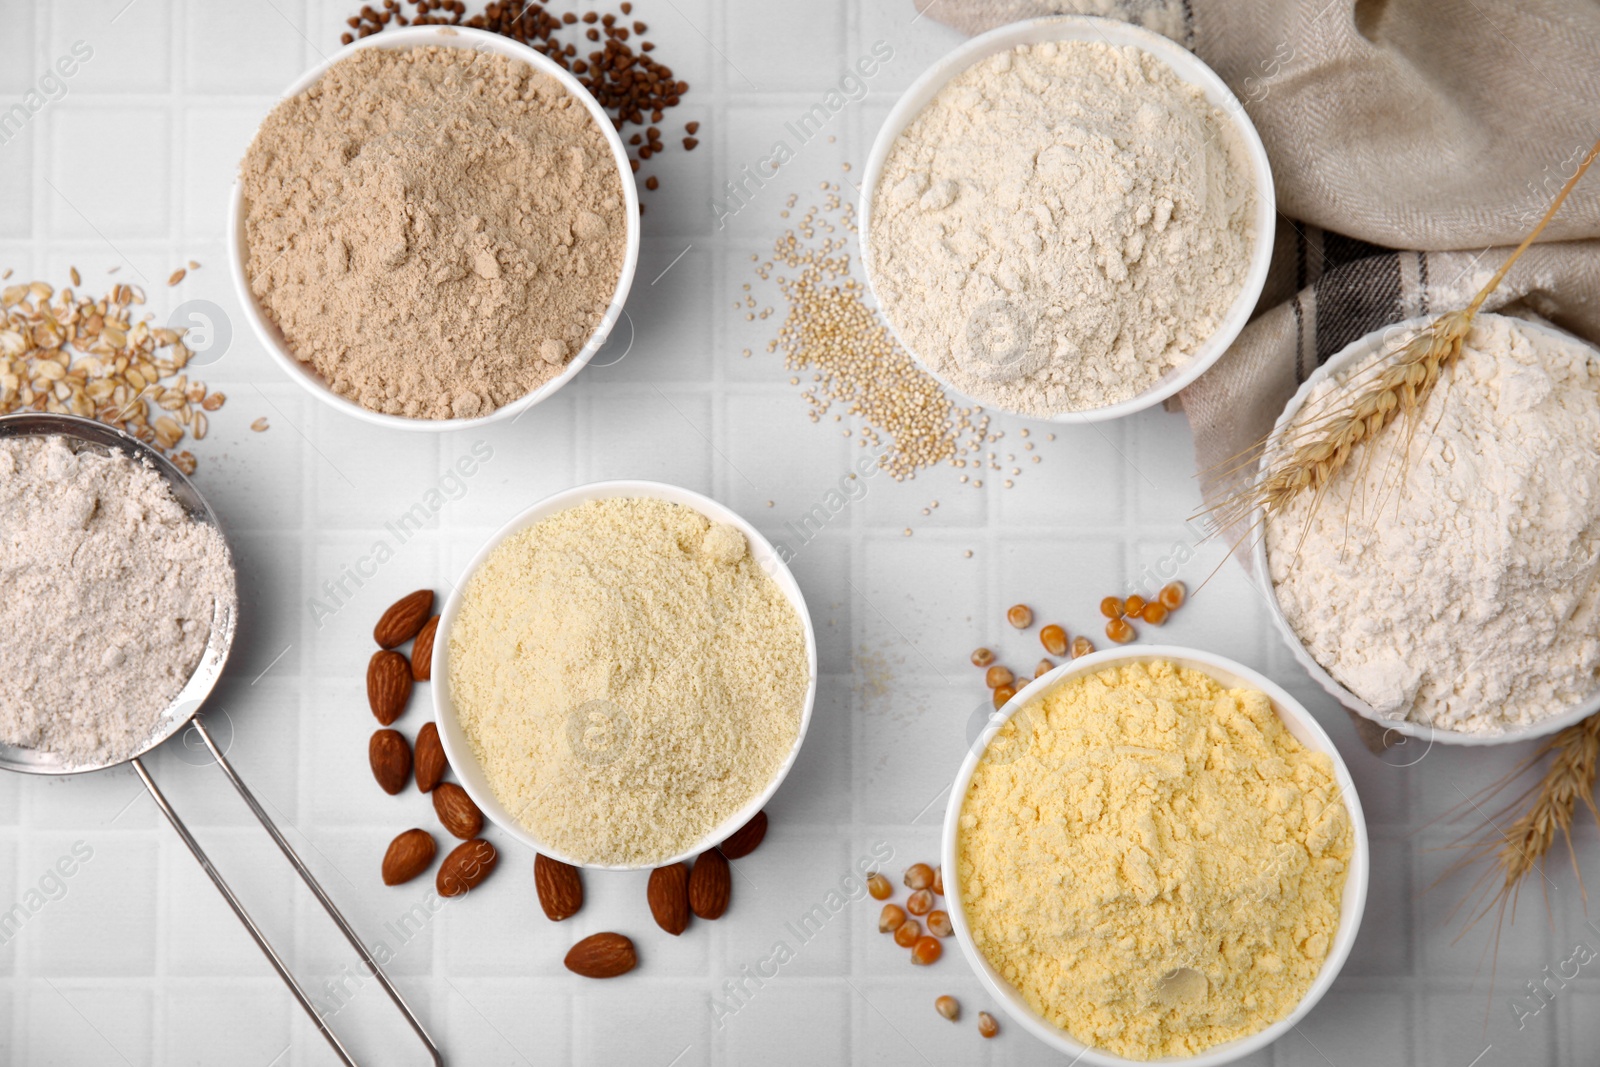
[1200,133,1600,549]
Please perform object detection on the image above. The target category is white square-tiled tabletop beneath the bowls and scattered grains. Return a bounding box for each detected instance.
[0,0,1600,1067]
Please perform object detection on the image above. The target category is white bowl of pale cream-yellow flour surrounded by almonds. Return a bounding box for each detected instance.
[432,482,816,870]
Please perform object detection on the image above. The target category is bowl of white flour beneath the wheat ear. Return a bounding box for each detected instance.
[1254,314,1600,745]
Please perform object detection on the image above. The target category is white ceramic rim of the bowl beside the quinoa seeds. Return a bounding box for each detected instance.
[861,14,1277,422]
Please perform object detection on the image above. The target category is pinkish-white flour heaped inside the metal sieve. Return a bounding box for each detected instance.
[0,437,234,765]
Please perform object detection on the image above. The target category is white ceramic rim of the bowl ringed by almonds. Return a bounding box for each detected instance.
[430,482,816,870]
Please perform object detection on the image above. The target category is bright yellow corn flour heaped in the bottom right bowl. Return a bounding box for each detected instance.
[957,662,1354,1059]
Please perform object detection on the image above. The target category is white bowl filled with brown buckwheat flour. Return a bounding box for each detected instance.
[229,27,638,430]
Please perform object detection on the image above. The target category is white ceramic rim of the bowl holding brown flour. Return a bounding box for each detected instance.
[227,26,638,430]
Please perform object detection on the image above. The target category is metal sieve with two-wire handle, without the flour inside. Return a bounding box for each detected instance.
[0,413,445,1067]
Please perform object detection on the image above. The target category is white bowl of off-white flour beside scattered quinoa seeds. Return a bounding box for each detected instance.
[861,16,1275,422]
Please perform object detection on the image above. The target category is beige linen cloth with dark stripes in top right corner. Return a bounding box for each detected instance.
[915,0,1600,742]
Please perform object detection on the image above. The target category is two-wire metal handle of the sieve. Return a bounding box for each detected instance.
[131,718,445,1067]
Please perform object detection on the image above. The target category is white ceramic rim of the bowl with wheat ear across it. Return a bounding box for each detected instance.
[1251,315,1600,748]
